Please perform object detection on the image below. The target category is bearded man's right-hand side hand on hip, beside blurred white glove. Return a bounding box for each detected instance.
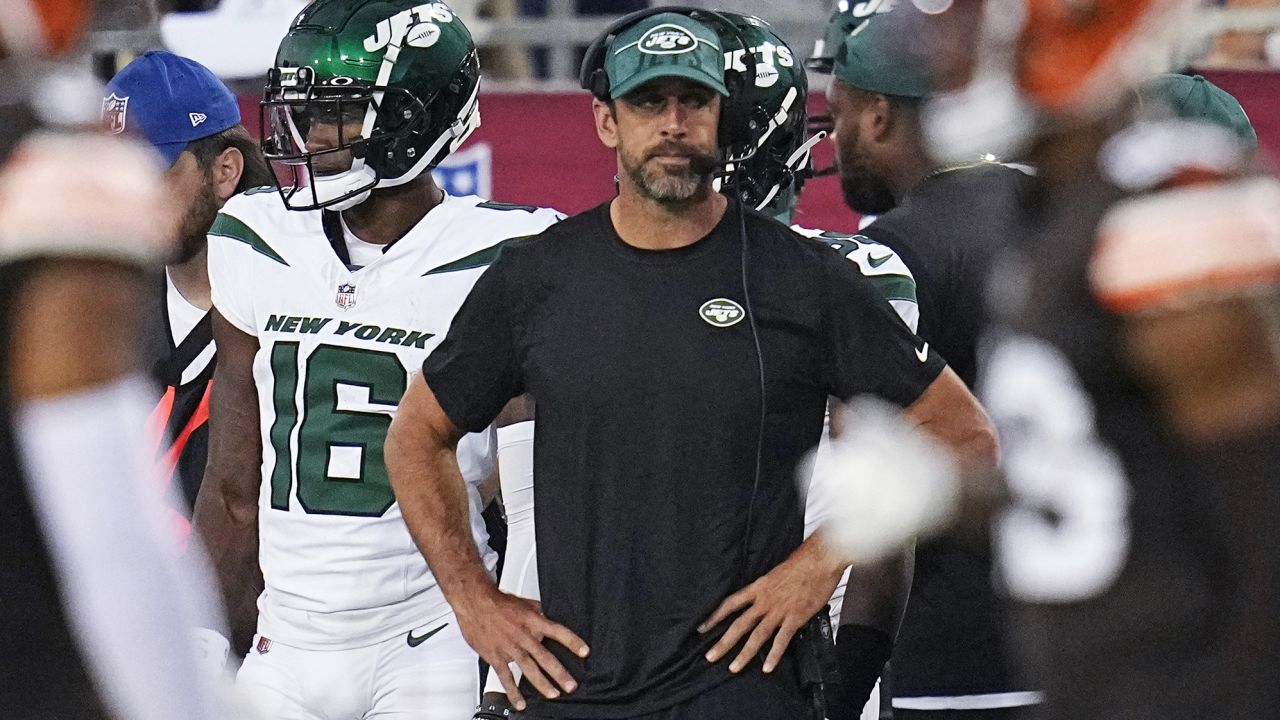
[698,536,845,673]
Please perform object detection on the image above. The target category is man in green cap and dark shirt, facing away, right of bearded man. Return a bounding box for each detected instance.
[809,3,1039,720]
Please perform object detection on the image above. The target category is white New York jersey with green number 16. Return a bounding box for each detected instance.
[209,191,561,650]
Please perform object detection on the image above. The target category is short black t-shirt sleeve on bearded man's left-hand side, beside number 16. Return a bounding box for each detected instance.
[422,252,524,433]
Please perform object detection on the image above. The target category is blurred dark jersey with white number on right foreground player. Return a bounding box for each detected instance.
[982,174,1280,720]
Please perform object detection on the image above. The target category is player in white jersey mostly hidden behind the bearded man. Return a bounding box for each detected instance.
[476,10,920,720]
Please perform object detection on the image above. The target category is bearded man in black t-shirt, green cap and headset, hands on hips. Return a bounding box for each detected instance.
[387,9,995,720]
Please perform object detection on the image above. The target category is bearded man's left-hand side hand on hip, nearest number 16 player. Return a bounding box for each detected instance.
[454,588,590,710]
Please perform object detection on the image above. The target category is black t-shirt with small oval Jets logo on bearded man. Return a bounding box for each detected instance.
[424,198,943,717]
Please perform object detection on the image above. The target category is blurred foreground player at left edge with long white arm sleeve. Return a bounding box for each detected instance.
[0,3,231,720]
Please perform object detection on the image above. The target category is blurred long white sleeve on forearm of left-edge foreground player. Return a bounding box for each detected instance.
[14,376,227,720]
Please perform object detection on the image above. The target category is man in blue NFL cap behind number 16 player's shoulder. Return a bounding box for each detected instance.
[102,50,271,546]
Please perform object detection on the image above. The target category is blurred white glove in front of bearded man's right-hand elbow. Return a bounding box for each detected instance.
[801,397,959,564]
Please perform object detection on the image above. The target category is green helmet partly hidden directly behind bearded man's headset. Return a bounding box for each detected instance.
[719,10,823,222]
